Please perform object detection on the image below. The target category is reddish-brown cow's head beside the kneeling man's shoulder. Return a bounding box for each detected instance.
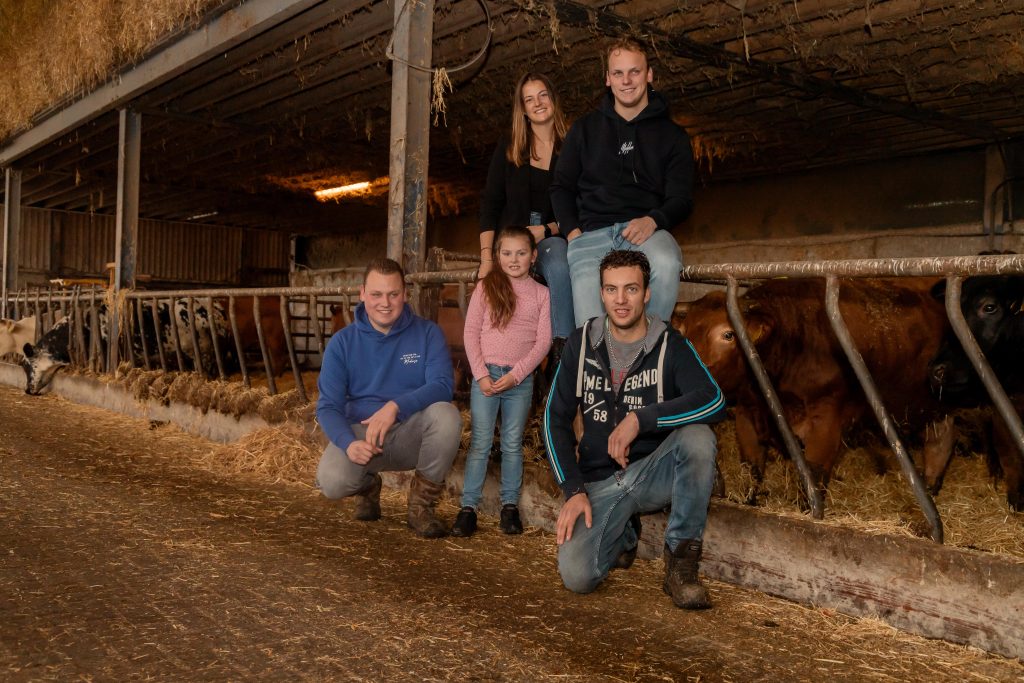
[679,292,772,397]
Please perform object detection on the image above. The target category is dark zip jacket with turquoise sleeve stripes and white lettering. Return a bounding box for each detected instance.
[544,315,725,499]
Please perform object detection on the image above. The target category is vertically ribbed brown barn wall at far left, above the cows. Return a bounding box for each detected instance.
[2,202,290,287]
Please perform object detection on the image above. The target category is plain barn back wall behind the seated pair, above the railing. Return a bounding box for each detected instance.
[428,145,1007,263]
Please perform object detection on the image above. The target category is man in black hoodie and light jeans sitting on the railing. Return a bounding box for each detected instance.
[551,39,693,325]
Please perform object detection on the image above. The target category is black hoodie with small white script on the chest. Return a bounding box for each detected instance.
[551,88,693,234]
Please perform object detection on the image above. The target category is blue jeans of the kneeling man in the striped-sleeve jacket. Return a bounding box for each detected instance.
[558,425,718,593]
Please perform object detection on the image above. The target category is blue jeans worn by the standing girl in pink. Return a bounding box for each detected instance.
[462,364,534,508]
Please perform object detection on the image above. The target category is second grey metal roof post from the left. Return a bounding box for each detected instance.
[108,109,142,372]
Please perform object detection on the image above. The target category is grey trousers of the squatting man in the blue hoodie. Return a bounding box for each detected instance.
[316,402,462,499]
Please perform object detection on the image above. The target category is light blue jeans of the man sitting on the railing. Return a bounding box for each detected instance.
[566,222,683,327]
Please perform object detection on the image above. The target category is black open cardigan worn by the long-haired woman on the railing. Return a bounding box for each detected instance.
[480,137,558,232]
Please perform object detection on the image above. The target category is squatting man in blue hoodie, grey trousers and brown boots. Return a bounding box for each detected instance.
[316,259,462,539]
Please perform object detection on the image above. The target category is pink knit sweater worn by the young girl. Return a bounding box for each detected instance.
[463,278,551,384]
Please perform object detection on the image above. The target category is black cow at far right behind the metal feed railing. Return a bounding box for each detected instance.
[929,275,1024,512]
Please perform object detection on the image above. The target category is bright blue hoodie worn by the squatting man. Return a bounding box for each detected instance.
[316,303,455,451]
